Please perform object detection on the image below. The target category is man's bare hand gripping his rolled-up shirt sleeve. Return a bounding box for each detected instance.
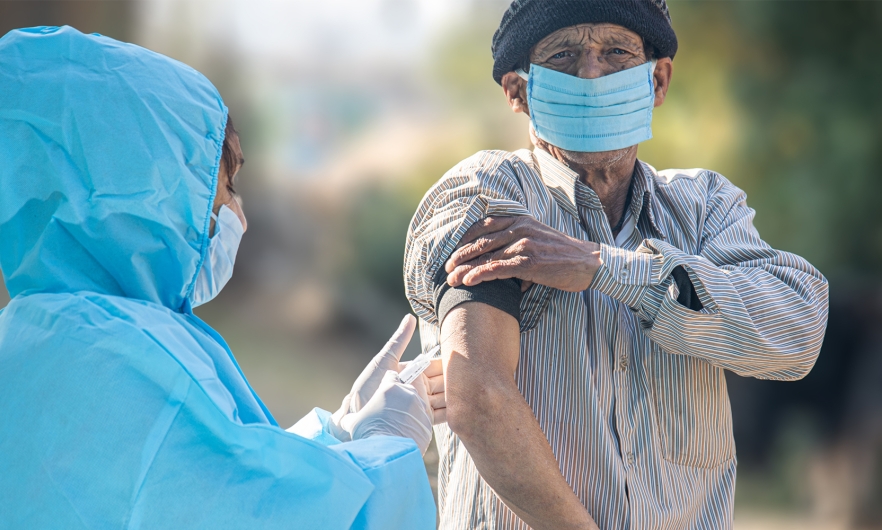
[445,216,602,292]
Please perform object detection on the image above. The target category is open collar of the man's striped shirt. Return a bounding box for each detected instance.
[533,147,666,239]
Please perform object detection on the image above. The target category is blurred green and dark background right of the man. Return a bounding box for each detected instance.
[660,1,882,526]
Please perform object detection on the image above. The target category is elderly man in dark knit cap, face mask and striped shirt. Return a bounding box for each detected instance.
[405,0,827,529]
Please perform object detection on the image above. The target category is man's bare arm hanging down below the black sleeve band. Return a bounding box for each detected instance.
[443,304,597,530]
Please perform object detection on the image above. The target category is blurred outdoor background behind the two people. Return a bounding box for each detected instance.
[0,0,882,530]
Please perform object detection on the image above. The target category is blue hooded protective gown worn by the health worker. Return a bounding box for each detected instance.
[0,27,435,529]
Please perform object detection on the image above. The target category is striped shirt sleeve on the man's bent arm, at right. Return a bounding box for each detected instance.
[591,176,828,380]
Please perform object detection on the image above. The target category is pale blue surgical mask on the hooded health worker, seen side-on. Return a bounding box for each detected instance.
[190,204,245,307]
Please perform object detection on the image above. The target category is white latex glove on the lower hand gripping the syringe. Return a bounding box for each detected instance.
[340,370,432,454]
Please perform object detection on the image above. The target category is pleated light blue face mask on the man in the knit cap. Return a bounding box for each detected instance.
[518,61,655,153]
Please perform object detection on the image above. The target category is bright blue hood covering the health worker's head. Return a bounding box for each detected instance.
[0,26,227,310]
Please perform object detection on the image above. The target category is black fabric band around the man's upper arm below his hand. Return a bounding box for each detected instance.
[434,266,523,325]
